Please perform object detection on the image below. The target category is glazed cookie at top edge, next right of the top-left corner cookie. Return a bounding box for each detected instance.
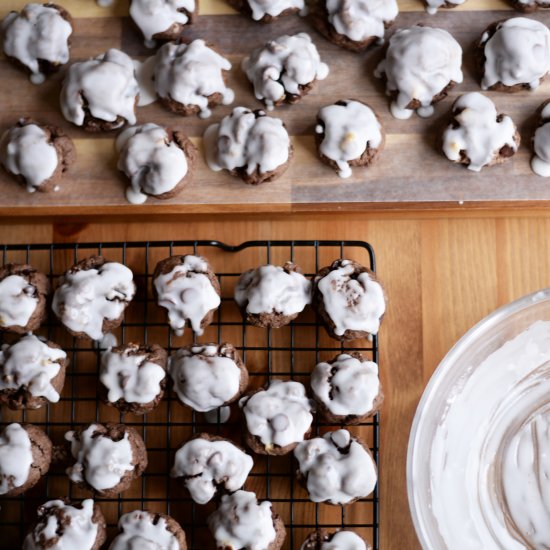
[130,0,199,48]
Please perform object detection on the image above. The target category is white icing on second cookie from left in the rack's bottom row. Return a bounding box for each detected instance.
[109,510,180,550]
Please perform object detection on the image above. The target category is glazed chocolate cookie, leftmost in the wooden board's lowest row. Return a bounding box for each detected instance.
[0,118,76,193]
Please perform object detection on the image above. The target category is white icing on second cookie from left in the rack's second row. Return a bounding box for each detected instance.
[99,346,166,403]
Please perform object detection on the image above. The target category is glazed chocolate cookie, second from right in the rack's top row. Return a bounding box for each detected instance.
[235,262,311,328]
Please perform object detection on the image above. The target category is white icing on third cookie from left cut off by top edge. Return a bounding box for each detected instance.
[325,0,399,42]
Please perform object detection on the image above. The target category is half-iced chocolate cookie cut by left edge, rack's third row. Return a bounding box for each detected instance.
[0,423,52,497]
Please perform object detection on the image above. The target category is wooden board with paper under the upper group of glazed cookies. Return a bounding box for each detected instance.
[0,0,550,215]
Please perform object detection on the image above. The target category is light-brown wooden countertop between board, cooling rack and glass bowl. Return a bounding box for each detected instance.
[0,210,550,550]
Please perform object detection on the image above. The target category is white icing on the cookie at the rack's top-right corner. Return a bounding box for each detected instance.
[315,260,386,336]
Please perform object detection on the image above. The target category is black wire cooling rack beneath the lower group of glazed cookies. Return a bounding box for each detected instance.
[0,241,380,550]
